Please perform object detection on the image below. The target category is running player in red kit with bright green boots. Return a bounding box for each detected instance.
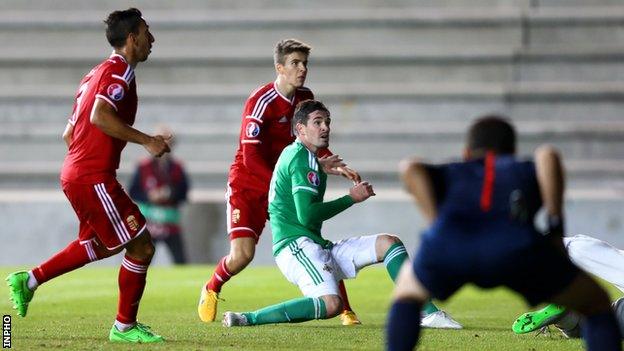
[7,8,171,343]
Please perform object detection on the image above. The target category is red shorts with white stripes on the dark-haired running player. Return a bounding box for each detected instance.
[61,179,145,250]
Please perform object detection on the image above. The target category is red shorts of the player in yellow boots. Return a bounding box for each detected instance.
[225,185,269,242]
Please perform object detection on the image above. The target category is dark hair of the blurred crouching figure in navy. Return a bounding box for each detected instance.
[467,115,516,154]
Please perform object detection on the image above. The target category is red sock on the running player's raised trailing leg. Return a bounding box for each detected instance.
[32,239,98,285]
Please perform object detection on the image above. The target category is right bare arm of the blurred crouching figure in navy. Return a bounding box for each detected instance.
[535,145,565,235]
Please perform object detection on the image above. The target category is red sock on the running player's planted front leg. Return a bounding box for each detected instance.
[117,255,149,324]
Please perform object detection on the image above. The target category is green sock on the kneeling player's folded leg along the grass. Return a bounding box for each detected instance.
[244,297,327,325]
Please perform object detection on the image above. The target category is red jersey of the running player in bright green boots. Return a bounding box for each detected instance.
[61,54,137,183]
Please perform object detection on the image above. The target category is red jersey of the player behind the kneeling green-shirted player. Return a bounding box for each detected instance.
[228,82,314,192]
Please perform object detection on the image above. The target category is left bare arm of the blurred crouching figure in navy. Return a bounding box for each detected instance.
[399,159,438,224]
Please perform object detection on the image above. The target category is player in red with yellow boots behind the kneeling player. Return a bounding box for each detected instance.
[197,39,361,325]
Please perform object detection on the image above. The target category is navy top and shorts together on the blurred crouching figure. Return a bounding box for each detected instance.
[413,154,578,305]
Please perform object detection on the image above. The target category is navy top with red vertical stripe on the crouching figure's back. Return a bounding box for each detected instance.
[428,155,542,249]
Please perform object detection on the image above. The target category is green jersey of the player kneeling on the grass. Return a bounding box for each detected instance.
[269,140,330,255]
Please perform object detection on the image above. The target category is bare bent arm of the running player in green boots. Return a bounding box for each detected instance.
[91,99,172,157]
